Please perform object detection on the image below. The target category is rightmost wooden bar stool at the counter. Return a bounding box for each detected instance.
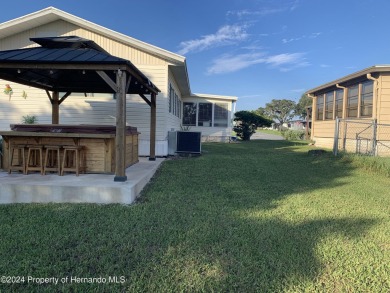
[61,145,85,176]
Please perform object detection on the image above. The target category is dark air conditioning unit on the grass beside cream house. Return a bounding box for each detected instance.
[168,131,202,155]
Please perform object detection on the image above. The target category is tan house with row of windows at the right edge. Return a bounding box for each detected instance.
[305,65,390,155]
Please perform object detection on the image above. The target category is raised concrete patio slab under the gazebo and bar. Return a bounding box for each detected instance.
[0,158,164,204]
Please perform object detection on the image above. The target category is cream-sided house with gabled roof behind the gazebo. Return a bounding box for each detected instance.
[0,7,237,156]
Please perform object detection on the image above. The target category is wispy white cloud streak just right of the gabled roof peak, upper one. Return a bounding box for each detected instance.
[178,25,248,55]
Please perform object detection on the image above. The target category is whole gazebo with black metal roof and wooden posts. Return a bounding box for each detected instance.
[0,36,160,182]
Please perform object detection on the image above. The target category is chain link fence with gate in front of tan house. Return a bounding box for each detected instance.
[333,119,390,157]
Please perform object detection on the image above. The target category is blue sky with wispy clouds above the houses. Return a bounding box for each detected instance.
[0,0,390,110]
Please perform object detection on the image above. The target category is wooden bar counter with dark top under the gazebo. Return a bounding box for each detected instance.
[0,124,139,174]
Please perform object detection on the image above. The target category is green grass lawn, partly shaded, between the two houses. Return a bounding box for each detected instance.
[0,140,390,292]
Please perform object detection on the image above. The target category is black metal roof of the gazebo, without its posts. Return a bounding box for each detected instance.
[0,36,160,95]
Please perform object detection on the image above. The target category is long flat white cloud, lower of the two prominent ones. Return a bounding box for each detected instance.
[207,53,309,75]
